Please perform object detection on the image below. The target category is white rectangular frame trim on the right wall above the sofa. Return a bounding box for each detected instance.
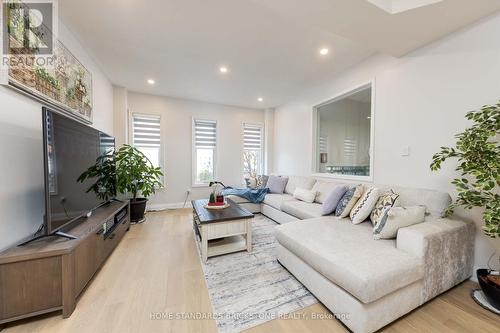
[311,79,376,182]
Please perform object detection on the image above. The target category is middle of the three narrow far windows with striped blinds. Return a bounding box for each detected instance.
[193,119,217,185]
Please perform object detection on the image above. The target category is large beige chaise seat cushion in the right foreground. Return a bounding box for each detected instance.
[275,217,423,304]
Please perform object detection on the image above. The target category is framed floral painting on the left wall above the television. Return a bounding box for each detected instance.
[1,3,93,123]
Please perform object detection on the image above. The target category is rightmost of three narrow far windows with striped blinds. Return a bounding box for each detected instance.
[243,124,264,178]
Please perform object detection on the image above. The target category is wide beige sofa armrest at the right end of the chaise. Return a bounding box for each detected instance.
[397,218,475,304]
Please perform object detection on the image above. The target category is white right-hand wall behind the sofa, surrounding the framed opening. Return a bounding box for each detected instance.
[274,15,500,266]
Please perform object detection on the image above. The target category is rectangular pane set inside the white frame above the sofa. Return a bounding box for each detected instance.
[313,82,374,180]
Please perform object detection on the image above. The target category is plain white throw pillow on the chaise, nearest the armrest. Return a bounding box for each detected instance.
[373,206,426,239]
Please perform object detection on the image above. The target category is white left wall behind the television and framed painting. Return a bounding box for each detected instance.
[0,23,113,250]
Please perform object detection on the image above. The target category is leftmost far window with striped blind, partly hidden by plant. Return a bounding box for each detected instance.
[132,114,163,169]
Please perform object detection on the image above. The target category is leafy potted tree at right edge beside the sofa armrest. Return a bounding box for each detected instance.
[431,102,500,310]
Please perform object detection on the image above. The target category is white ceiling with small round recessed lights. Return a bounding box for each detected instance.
[59,0,500,108]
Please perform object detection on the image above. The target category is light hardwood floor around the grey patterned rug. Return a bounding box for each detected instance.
[2,209,500,333]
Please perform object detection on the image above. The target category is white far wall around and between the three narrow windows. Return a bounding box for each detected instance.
[125,92,265,209]
